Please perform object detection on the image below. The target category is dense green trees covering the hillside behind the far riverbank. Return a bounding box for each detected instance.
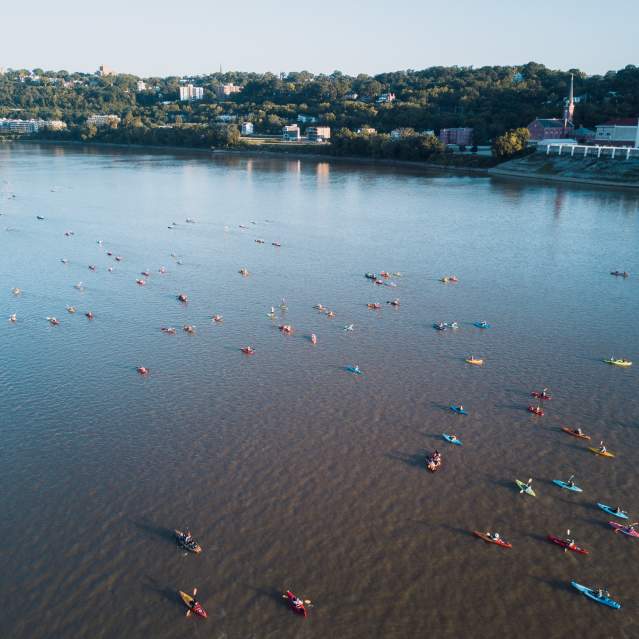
[0,62,639,156]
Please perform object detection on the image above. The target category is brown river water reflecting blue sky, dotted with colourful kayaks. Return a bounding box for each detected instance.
[0,145,639,639]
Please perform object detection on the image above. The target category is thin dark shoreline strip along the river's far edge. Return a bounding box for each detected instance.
[8,139,639,191]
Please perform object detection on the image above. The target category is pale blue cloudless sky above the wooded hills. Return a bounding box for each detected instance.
[0,0,639,76]
